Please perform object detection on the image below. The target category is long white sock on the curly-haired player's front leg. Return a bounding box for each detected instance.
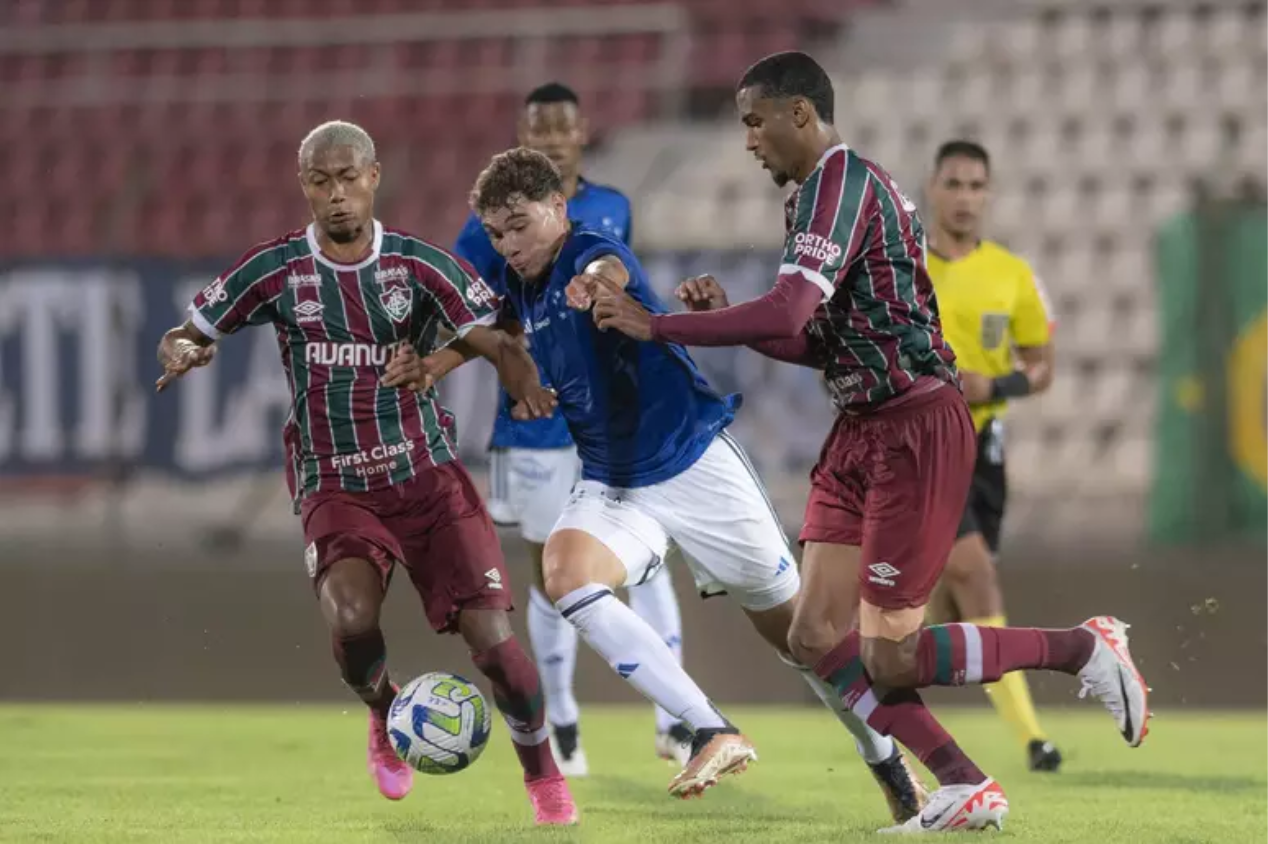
[555,583,727,730]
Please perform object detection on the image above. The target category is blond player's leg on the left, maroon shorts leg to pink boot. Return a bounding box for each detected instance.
[303,493,413,800]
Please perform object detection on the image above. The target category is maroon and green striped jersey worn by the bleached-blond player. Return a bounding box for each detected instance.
[190,221,501,504]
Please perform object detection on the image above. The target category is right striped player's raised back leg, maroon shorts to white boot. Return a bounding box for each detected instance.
[860,390,1149,746]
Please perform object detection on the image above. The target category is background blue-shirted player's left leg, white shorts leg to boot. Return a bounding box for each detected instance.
[503,449,590,777]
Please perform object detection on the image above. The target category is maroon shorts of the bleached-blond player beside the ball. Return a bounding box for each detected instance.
[301,460,512,632]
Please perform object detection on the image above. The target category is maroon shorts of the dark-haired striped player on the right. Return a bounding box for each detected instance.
[800,385,978,610]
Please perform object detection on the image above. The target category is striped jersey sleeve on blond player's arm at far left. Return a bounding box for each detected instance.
[189,241,287,340]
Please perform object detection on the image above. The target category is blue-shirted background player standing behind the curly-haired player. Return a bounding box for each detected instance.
[454,82,691,777]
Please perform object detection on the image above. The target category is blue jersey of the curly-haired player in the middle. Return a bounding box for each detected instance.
[500,223,739,488]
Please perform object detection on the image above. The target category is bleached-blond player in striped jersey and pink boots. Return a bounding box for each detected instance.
[157,122,577,824]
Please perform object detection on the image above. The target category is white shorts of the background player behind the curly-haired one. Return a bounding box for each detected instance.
[488,447,581,544]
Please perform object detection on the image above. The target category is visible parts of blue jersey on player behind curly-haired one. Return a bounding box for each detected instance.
[454,179,633,449]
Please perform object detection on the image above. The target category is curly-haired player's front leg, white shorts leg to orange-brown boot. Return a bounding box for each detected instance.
[545,480,756,797]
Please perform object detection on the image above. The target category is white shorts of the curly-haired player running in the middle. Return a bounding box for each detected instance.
[554,431,801,612]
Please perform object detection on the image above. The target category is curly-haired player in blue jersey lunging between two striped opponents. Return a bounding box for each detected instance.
[424,148,923,819]
